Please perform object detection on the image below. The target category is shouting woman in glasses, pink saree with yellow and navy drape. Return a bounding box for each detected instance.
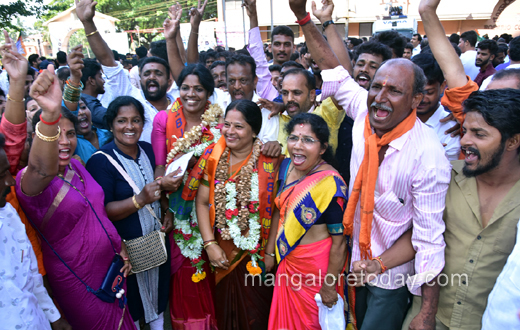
[265,113,347,330]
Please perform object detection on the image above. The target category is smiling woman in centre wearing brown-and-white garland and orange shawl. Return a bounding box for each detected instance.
[196,100,280,330]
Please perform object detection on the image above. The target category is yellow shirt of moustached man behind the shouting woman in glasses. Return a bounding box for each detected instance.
[278,97,345,157]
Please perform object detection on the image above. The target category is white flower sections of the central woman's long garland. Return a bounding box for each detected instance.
[225,172,262,251]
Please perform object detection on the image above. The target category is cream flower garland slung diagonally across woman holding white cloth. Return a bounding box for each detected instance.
[166,104,224,164]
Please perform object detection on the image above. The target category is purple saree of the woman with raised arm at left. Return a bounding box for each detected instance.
[16,159,135,330]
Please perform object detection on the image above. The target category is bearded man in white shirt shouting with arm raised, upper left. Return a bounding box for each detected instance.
[76,0,175,142]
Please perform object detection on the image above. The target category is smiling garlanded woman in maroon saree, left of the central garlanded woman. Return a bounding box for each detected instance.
[152,64,222,329]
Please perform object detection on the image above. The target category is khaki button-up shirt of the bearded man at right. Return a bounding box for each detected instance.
[437,160,520,330]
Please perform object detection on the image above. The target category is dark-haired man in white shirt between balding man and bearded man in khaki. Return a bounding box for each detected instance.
[412,53,460,161]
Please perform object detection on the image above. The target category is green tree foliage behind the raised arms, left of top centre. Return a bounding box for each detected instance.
[40,0,217,46]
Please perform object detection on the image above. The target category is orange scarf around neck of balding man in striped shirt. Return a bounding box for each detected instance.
[343,109,417,260]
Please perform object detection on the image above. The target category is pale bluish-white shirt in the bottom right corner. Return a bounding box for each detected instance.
[482,218,520,330]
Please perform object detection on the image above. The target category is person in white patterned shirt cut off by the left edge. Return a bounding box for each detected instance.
[0,134,72,330]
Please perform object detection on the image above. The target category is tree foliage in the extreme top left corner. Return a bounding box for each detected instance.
[0,0,47,31]
